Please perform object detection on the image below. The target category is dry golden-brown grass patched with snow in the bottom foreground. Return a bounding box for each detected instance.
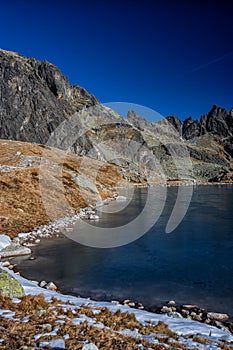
[0,295,191,350]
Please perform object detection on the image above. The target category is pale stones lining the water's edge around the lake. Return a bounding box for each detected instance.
[0,183,233,340]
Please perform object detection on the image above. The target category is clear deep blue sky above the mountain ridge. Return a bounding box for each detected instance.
[0,0,233,119]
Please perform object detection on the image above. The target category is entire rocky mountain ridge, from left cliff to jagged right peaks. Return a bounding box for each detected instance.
[0,50,233,184]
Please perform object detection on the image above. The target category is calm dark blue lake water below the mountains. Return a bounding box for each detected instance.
[15,185,233,315]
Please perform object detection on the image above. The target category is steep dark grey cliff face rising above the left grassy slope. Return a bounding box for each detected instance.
[0,50,98,143]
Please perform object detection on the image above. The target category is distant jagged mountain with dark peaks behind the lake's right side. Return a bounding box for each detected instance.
[127,105,233,182]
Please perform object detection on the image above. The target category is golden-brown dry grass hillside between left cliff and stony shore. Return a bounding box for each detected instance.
[0,140,125,237]
